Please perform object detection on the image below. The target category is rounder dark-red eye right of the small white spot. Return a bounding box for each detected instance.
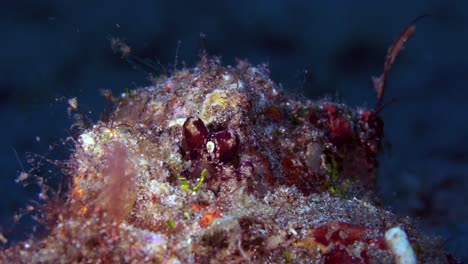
[207,130,239,162]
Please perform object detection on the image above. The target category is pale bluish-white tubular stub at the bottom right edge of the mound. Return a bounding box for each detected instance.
[385,226,416,264]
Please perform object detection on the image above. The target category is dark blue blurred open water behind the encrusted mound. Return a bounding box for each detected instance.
[0,0,468,261]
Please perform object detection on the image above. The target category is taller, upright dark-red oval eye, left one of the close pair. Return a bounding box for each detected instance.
[182,117,209,160]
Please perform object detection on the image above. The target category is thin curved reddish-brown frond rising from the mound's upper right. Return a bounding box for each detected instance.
[372,14,429,113]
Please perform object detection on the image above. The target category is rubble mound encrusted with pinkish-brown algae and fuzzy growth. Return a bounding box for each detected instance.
[0,27,460,263]
